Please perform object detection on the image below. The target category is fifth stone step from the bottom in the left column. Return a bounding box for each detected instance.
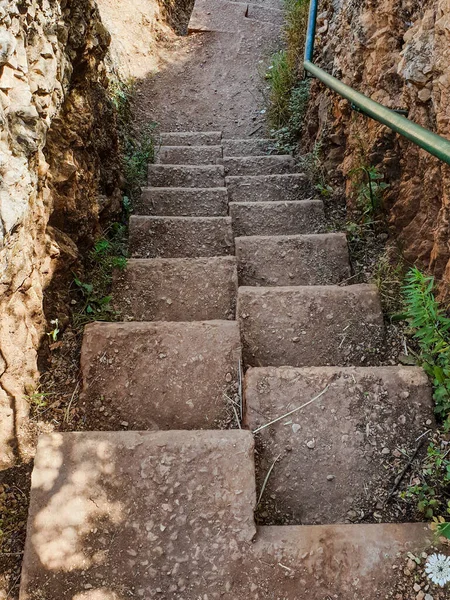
[135,188,228,217]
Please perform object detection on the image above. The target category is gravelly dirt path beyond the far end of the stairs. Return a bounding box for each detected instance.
[135,24,279,137]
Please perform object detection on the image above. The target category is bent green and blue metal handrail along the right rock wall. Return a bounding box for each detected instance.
[303,0,450,165]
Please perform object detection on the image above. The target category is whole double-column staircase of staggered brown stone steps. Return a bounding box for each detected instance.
[21,131,433,600]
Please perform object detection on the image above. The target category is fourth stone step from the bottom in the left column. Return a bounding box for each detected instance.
[129,215,234,258]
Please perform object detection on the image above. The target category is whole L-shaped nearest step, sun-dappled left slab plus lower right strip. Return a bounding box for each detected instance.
[20,431,432,600]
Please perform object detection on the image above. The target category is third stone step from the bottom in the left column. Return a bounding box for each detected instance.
[113,256,237,321]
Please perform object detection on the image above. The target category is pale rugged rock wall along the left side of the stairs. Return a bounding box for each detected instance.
[0,0,121,469]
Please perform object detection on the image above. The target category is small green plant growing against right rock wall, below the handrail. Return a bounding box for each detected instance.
[349,165,389,221]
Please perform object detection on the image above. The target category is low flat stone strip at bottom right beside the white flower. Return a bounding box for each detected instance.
[251,523,430,600]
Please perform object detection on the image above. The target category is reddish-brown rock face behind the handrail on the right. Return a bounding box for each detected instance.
[305,0,450,296]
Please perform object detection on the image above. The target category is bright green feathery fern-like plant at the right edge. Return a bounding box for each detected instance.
[404,267,450,422]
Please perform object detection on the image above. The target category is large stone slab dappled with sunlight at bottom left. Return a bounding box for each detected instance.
[20,431,255,600]
